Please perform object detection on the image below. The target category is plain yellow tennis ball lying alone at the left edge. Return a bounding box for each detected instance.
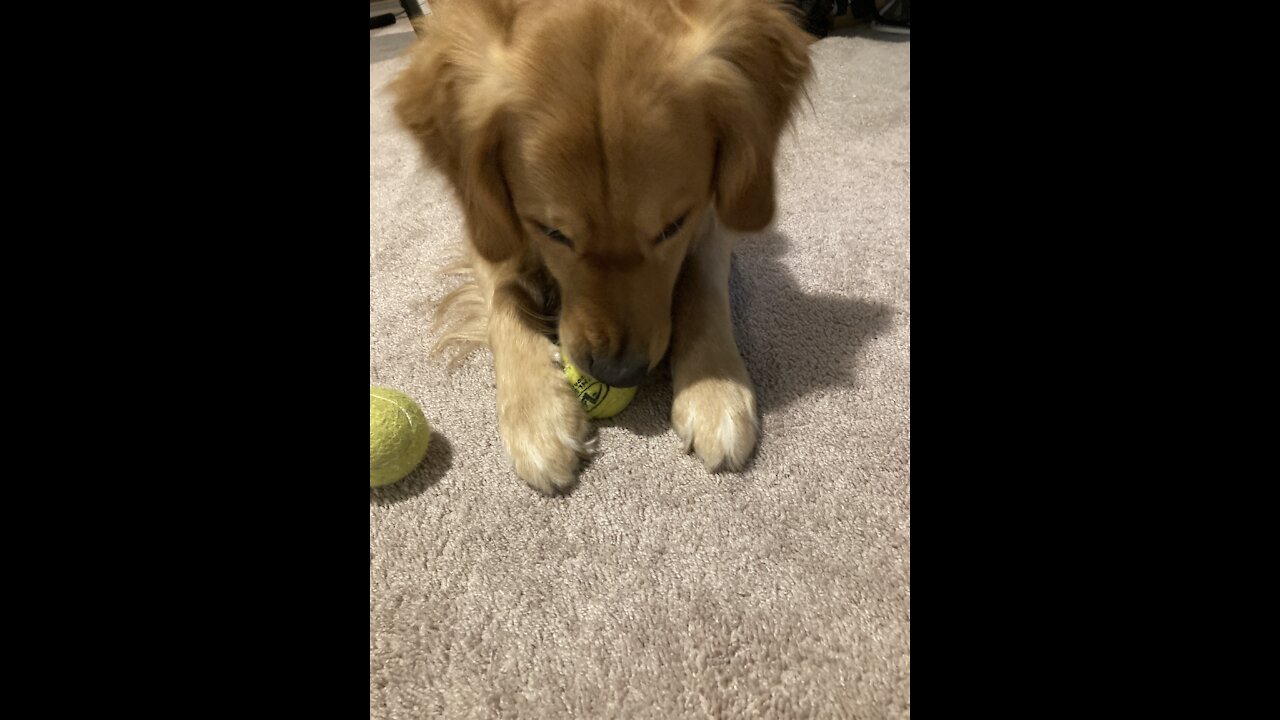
[369,387,431,487]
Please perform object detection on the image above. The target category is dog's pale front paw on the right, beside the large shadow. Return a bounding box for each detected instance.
[671,377,760,471]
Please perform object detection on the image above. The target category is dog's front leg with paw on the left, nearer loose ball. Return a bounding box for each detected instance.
[474,258,593,495]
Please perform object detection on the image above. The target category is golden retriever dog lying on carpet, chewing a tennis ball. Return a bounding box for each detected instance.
[392,0,810,493]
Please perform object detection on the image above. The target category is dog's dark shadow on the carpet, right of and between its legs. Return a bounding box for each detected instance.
[607,226,893,437]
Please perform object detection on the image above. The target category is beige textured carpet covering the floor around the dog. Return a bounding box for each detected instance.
[369,20,911,719]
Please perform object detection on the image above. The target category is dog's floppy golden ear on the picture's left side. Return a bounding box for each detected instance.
[392,0,524,263]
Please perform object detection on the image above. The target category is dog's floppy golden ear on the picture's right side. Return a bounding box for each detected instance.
[686,0,810,232]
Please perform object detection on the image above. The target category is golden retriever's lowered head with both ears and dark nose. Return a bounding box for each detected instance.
[394,0,809,386]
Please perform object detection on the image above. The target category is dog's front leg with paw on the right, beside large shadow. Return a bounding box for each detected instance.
[671,219,759,470]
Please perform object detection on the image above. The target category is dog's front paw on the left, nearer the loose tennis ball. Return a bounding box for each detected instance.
[498,366,595,495]
